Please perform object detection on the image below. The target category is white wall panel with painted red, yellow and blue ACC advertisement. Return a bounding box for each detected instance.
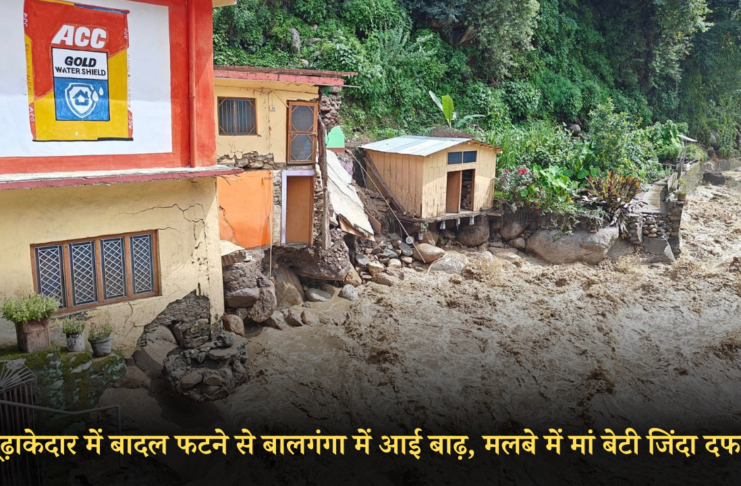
[0,0,172,157]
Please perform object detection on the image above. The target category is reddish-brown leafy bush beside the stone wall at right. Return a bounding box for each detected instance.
[577,171,645,235]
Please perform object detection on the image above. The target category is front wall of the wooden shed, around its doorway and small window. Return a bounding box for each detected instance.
[422,143,497,218]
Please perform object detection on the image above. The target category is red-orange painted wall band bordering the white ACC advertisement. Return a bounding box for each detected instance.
[0,0,216,174]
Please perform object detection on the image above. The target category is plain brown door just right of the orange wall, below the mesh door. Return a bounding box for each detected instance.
[283,176,314,245]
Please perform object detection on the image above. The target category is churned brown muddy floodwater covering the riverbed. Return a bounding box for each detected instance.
[95,177,741,485]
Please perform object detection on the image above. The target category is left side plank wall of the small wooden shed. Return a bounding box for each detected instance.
[367,150,425,215]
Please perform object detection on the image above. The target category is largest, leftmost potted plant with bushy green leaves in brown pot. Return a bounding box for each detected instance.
[3,294,59,353]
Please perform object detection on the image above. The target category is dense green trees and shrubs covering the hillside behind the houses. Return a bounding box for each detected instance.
[214,0,741,217]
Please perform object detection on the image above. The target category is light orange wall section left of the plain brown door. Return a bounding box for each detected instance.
[218,170,273,249]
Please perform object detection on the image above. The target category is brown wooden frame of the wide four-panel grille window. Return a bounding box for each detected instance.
[31,230,162,315]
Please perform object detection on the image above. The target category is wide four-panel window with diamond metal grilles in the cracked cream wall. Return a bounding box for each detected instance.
[32,232,159,310]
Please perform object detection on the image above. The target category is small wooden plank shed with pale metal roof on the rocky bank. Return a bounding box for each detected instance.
[361,136,501,220]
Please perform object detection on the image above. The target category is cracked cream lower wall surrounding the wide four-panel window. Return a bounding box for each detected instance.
[0,178,224,353]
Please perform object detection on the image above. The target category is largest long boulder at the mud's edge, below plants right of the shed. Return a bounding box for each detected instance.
[527,228,619,265]
